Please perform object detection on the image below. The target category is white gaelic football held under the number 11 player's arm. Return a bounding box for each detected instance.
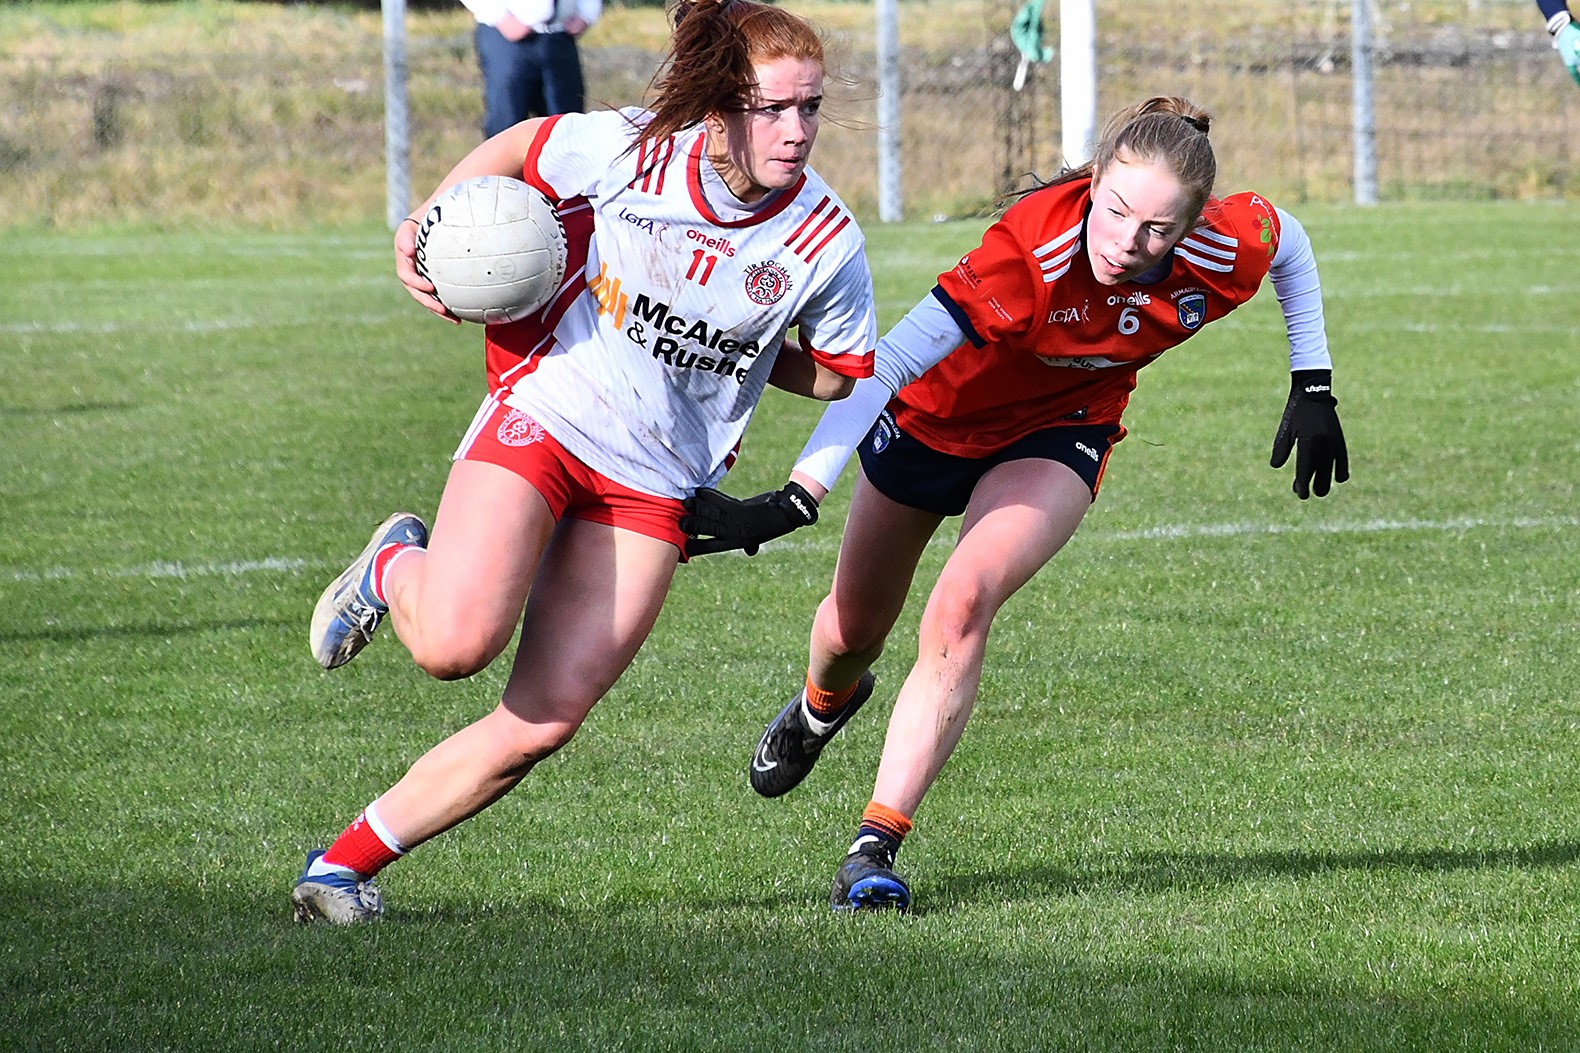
[417,176,566,324]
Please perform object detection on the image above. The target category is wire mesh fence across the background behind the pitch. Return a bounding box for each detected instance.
[0,0,1580,223]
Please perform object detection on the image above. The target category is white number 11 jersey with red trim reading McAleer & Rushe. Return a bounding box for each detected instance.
[488,109,877,496]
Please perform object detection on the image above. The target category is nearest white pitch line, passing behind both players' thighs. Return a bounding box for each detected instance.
[15,515,1580,582]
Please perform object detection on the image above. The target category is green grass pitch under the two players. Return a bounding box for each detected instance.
[0,204,1580,1053]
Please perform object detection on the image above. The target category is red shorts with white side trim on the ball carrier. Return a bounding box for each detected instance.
[455,395,686,553]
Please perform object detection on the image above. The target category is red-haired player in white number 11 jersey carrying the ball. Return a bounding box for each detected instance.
[291,0,877,923]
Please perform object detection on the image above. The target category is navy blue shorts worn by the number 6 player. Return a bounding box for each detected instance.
[860,410,1119,515]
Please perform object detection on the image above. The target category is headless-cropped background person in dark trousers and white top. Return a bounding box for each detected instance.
[461,0,604,139]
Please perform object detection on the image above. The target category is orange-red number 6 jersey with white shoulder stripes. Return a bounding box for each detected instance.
[896,179,1278,457]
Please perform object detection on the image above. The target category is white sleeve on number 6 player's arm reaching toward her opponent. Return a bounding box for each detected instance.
[795,294,965,490]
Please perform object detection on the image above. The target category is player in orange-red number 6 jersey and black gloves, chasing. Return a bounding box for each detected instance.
[681,98,1349,911]
